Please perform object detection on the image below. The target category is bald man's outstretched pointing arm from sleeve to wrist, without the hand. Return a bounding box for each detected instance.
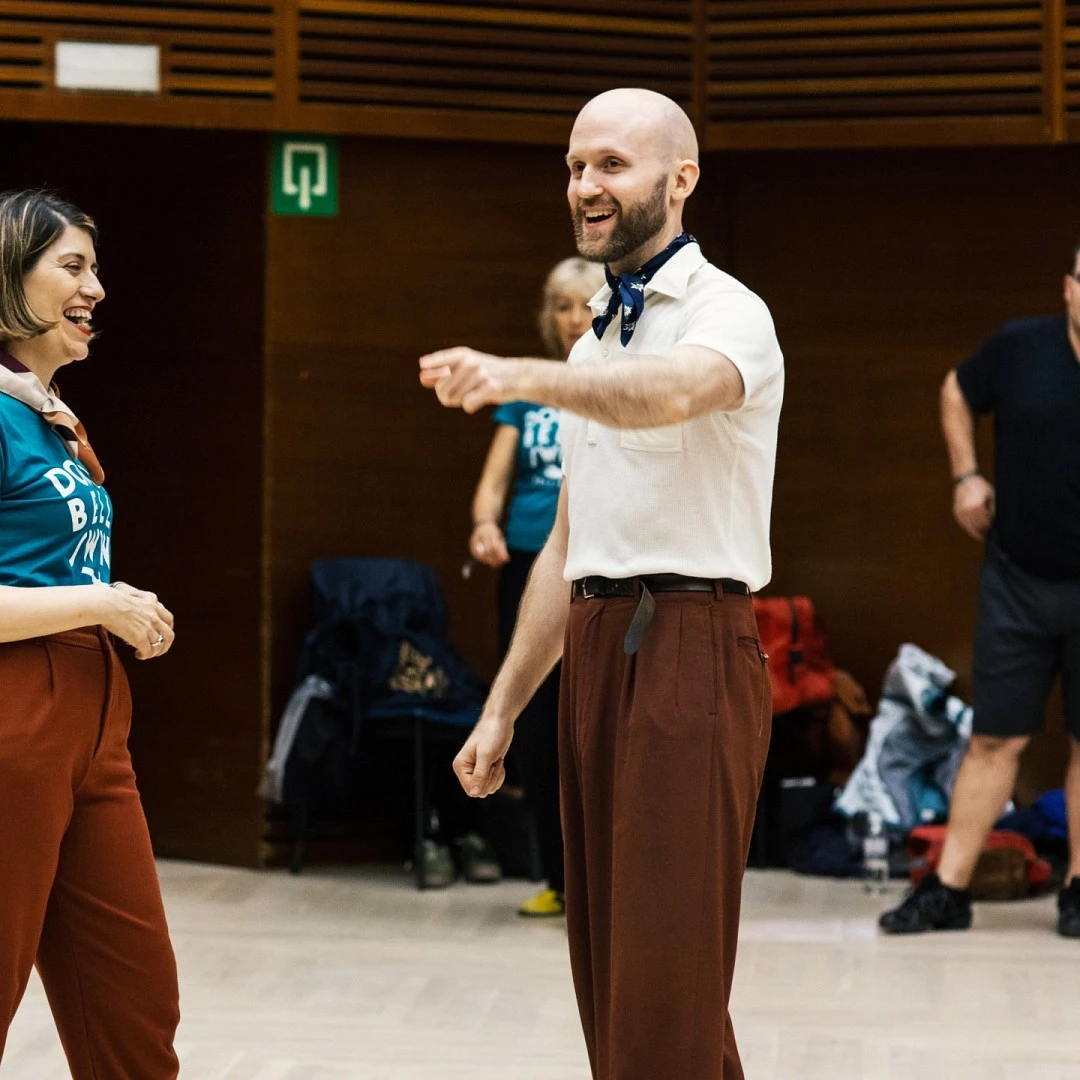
[513,350,743,428]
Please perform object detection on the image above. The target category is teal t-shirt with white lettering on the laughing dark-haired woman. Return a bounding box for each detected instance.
[0,393,112,585]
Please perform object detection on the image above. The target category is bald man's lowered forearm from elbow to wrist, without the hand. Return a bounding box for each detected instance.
[484,542,570,720]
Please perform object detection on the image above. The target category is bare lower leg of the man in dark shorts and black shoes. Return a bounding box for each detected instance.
[937,735,1028,889]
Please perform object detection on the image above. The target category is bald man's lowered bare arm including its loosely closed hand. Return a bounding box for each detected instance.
[454,481,570,798]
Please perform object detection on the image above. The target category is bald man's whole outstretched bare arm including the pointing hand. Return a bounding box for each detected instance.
[420,345,745,428]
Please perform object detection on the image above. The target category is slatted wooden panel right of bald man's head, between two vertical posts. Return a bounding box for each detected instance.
[707,0,1043,132]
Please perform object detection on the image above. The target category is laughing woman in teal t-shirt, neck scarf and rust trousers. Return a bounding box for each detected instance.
[0,191,178,1080]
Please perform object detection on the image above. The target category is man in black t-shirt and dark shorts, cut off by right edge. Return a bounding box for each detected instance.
[881,244,1080,937]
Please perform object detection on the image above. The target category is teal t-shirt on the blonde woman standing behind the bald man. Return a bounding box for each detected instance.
[494,402,563,552]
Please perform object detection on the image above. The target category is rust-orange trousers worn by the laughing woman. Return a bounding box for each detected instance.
[0,629,179,1080]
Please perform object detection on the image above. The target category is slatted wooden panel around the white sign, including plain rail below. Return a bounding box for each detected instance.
[0,0,285,127]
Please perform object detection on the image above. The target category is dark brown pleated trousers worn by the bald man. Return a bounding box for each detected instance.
[559,593,772,1080]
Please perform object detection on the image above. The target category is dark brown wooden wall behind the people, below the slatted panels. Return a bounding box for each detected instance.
[2,123,1080,863]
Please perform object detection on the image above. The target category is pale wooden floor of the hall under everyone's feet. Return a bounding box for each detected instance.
[0,862,1080,1080]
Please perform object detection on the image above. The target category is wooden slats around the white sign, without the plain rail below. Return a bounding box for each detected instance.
[0,0,274,102]
